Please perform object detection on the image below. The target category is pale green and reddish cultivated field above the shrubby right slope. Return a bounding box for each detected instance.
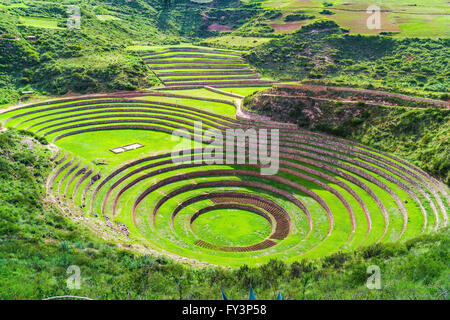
[248,0,450,37]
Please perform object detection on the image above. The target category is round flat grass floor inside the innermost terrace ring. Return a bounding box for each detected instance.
[192,209,271,246]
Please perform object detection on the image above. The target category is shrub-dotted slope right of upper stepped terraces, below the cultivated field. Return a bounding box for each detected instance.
[245,21,450,98]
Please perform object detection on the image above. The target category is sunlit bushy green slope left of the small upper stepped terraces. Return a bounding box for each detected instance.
[0,2,163,104]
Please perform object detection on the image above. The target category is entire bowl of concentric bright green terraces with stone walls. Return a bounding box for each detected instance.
[0,88,449,266]
